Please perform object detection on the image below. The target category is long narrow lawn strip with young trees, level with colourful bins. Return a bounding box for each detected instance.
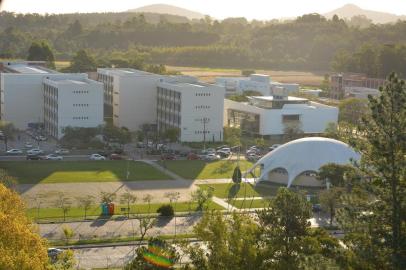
[27,201,224,219]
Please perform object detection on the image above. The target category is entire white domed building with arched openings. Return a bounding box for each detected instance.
[247,137,360,187]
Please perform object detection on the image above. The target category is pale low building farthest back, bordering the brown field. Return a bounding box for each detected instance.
[216,74,299,96]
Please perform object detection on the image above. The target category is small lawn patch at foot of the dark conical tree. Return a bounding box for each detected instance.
[199,183,278,198]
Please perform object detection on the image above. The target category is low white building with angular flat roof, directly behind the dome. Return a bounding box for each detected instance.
[224,96,338,136]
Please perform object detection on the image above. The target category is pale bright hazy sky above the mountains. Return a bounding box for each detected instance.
[1,0,406,19]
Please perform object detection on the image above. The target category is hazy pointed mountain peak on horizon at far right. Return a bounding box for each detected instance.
[323,4,406,23]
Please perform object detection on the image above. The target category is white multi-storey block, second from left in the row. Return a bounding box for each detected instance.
[43,78,103,139]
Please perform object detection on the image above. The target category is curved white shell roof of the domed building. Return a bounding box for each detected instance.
[253,137,360,187]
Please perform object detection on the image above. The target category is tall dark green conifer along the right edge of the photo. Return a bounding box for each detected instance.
[339,73,406,269]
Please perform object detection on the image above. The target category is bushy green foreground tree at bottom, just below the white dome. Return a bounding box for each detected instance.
[258,188,339,269]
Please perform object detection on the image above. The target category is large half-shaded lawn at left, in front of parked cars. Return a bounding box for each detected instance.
[0,160,171,184]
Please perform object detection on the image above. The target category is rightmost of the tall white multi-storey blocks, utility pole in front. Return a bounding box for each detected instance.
[156,76,225,142]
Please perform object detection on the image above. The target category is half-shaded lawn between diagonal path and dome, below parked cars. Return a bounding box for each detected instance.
[159,160,253,179]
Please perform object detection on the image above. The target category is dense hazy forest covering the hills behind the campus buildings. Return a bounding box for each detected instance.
[0,12,406,77]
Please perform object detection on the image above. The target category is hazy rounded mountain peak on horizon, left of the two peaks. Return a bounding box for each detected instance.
[128,4,204,20]
